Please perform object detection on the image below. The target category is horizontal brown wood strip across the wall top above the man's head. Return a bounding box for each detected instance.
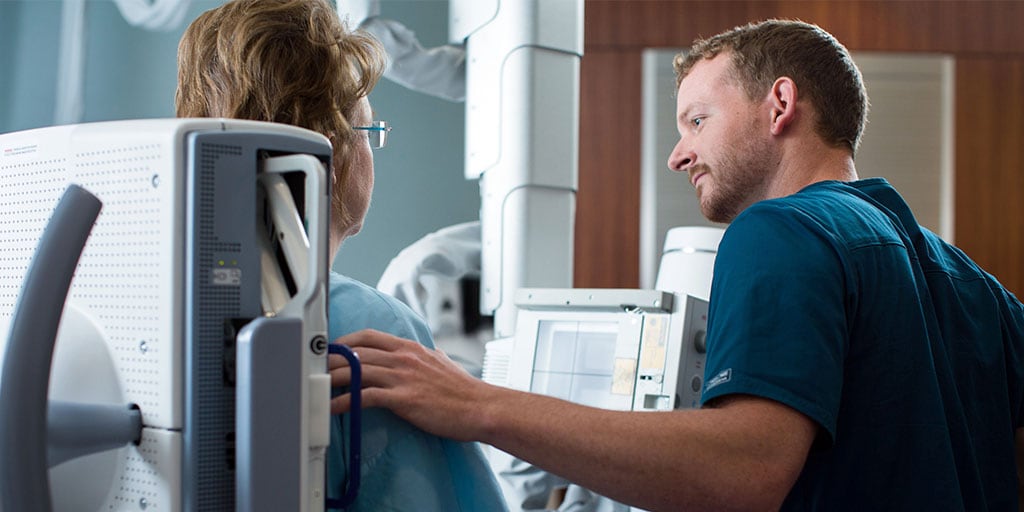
[585,0,1024,53]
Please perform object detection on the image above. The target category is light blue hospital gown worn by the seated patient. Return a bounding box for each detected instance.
[328,272,507,512]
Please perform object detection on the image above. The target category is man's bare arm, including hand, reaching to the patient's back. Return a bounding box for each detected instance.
[331,331,817,510]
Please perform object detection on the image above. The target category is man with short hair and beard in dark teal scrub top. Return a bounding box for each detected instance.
[334,20,1024,511]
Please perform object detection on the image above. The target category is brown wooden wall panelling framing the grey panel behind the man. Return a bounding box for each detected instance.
[574,0,1024,294]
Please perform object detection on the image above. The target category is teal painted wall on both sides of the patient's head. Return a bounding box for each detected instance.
[0,0,479,285]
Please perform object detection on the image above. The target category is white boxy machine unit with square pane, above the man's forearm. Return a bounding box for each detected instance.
[499,289,708,411]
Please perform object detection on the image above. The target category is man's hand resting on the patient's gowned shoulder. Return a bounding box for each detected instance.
[328,330,499,440]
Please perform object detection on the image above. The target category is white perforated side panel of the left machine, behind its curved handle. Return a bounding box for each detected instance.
[0,121,190,510]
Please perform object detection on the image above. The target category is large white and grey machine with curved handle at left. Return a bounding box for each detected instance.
[0,119,358,511]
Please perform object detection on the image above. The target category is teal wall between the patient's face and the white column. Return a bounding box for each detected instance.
[335,0,480,285]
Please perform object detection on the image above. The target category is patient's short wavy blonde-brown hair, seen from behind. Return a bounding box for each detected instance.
[174,0,386,234]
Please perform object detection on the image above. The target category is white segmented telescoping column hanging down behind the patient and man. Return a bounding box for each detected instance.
[449,0,584,337]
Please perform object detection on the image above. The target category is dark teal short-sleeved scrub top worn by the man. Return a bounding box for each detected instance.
[701,178,1024,511]
